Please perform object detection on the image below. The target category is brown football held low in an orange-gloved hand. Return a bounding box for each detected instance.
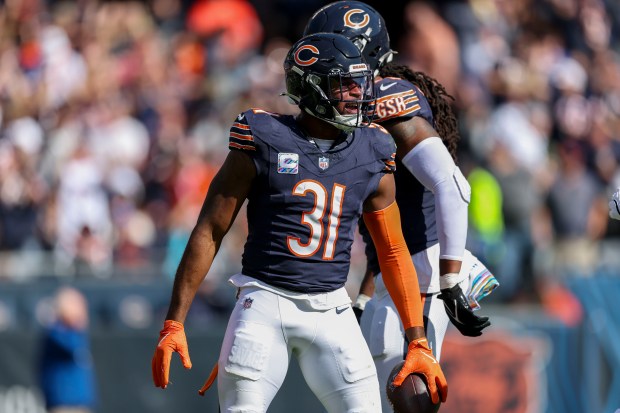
[386,360,441,413]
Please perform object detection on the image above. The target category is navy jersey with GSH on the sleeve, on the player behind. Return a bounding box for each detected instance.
[360,77,439,273]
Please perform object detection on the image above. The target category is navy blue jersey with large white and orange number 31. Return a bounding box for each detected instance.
[229,110,396,293]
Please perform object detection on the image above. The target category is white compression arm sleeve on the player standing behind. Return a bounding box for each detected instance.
[402,137,471,260]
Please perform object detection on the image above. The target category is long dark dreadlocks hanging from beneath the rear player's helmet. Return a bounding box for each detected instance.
[380,63,460,162]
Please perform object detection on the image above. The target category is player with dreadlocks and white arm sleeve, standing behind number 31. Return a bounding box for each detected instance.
[304,1,498,412]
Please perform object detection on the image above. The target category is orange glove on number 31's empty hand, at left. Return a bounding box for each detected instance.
[151,320,192,389]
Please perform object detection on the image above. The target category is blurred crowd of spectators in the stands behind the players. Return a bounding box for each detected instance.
[0,0,620,301]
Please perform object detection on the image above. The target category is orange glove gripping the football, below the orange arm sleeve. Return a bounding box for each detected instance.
[392,338,448,404]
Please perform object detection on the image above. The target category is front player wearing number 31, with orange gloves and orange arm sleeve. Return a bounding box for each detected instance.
[152,33,447,413]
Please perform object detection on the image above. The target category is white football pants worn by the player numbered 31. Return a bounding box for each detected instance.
[217,286,382,413]
